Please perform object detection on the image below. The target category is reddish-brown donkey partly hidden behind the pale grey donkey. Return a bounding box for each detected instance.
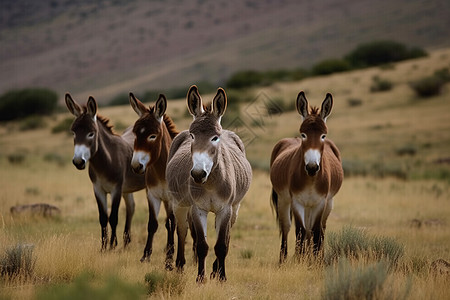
[130,93,178,270]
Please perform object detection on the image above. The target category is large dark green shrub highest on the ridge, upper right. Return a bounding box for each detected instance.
[345,41,427,68]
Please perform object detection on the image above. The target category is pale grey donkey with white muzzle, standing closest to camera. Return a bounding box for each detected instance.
[166,85,252,283]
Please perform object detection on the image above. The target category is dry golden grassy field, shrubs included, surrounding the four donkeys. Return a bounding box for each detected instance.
[0,50,450,299]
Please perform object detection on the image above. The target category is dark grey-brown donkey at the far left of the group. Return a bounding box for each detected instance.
[65,93,145,250]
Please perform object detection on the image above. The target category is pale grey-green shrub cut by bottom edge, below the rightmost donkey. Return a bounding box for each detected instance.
[322,260,388,300]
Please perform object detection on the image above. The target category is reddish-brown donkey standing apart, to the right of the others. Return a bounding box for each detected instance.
[270,92,344,263]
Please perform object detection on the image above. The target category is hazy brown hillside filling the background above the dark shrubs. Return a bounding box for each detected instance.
[0,0,450,101]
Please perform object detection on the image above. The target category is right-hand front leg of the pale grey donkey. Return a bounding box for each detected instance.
[211,206,232,281]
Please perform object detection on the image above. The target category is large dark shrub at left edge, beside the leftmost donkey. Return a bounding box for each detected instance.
[0,88,58,121]
